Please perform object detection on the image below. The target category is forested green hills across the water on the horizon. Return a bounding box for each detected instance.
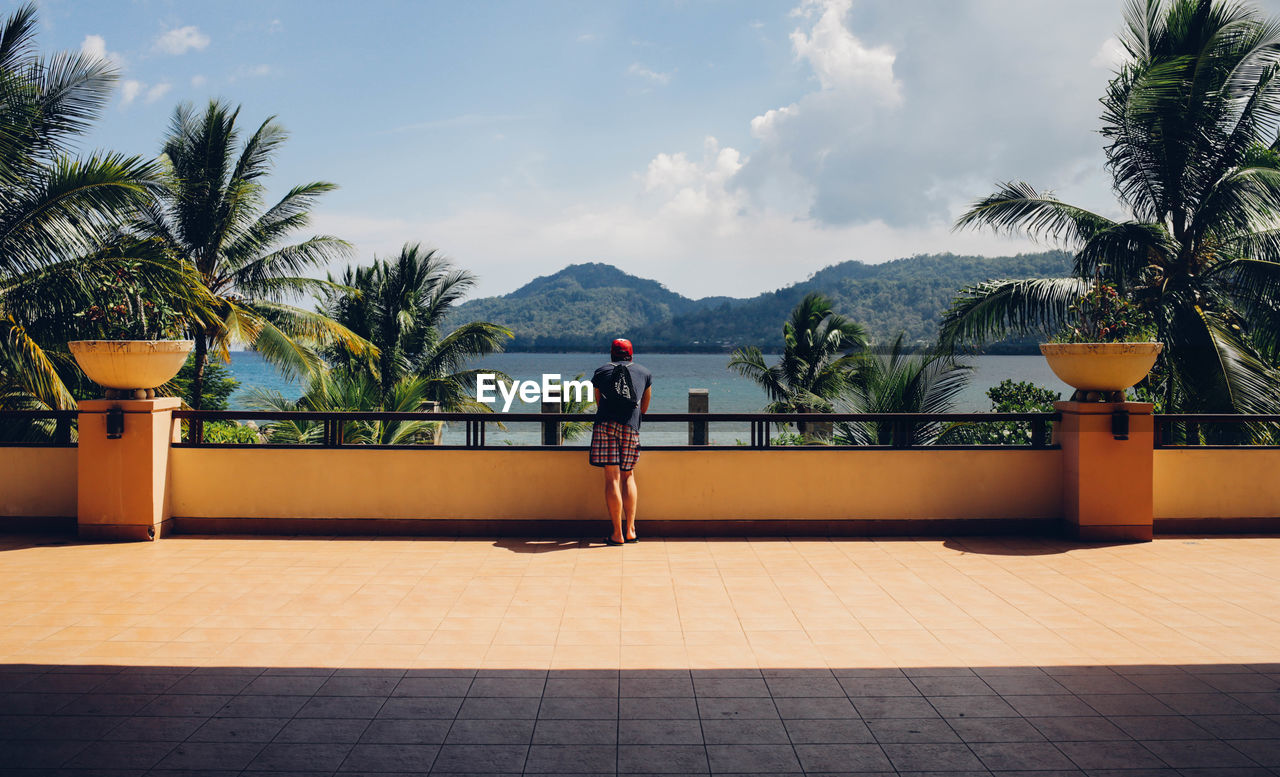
[451,251,1071,351]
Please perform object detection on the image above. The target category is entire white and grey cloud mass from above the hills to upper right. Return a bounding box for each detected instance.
[309,0,1120,296]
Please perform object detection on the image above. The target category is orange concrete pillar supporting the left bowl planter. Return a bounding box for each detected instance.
[77,397,182,540]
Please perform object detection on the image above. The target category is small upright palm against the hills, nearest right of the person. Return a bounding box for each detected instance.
[728,292,867,434]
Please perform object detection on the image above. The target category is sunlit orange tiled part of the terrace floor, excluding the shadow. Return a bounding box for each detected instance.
[0,536,1280,669]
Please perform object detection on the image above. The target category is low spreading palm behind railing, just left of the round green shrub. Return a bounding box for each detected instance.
[836,334,972,445]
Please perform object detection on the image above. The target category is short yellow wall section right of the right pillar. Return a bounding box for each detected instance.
[1153,448,1280,520]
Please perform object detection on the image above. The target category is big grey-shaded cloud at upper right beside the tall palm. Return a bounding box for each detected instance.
[732,0,1119,227]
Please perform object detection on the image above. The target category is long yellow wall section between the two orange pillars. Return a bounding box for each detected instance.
[170,448,1062,520]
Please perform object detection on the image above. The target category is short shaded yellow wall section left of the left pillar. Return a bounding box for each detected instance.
[0,447,76,517]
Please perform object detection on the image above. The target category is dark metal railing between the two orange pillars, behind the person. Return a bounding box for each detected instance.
[165,410,1059,449]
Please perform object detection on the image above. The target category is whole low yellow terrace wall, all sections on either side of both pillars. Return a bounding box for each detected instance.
[0,424,1280,534]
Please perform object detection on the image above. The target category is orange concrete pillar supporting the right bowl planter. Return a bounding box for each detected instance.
[1053,402,1155,541]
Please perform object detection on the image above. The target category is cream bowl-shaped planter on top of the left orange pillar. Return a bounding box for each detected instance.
[67,340,196,399]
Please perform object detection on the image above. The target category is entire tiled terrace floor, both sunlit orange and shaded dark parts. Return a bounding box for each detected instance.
[0,538,1280,777]
